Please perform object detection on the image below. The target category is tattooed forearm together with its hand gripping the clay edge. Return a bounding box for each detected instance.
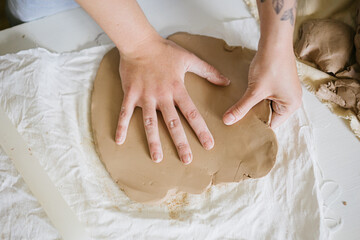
[223,0,302,128]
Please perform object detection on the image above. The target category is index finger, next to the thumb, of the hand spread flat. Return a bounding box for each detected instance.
[175,88,214,150]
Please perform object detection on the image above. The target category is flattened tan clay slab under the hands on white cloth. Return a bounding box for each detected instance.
[91,33,277,203]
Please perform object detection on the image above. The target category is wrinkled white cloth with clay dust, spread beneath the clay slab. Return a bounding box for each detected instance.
[0,46,329,239]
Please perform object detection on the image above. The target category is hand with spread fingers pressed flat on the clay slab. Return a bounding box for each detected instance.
[115,36,230,164]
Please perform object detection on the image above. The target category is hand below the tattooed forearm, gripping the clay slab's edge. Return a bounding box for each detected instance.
[223,44,302,128]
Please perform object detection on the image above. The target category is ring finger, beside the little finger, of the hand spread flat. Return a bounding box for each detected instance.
[142,103,163,163]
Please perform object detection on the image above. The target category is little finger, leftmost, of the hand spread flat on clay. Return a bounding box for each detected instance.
[115,95,135,145]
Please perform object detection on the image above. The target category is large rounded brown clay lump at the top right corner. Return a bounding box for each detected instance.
[295,19,354,74]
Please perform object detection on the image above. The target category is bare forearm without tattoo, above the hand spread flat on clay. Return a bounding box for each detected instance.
[77,0,159,55]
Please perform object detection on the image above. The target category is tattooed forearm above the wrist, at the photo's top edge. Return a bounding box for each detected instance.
[257,0,296,51]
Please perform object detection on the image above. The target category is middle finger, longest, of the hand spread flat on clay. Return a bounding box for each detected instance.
[160,103,192,164]
